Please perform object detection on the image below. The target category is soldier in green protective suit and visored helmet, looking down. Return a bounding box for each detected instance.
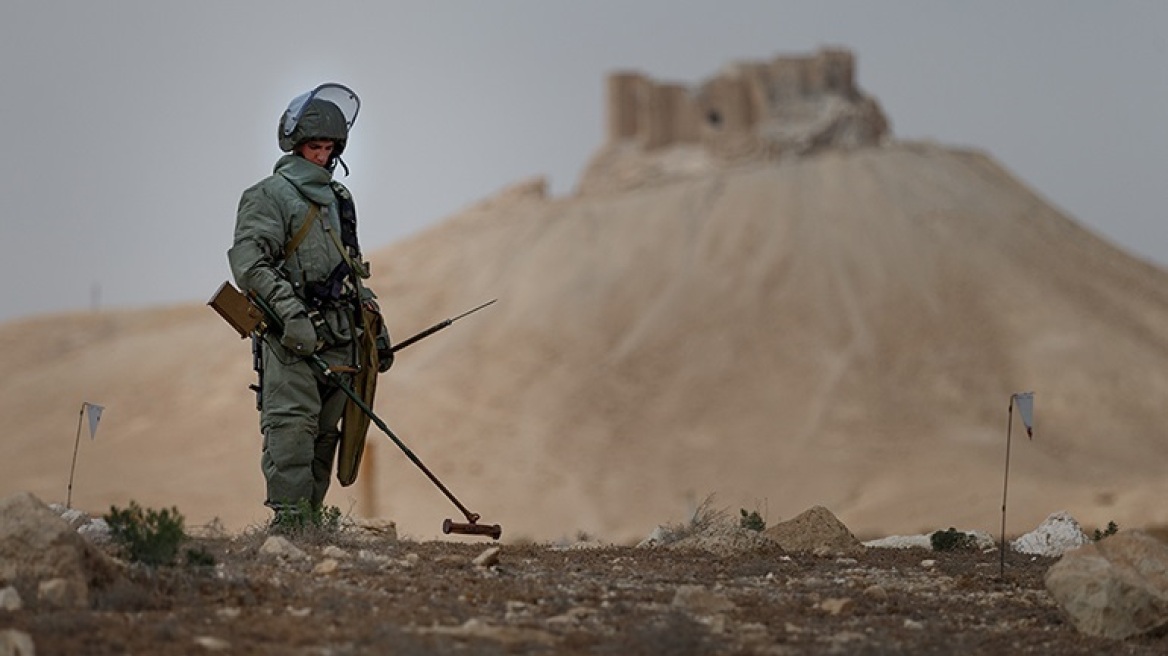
[228,84,392,528]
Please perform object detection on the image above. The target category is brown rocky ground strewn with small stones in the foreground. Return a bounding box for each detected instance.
[0,520,1168,656]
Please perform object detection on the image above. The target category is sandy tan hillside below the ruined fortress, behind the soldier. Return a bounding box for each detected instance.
[0,145,1168,540]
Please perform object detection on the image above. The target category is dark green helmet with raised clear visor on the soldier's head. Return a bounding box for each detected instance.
[276,83,361,158]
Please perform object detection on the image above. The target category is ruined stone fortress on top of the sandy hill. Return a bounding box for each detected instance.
[577,49,889,193]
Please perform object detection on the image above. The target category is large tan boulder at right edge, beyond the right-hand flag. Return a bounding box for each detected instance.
[1045,531,1168,640]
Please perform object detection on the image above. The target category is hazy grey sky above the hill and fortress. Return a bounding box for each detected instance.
[0,0,1168,321]
